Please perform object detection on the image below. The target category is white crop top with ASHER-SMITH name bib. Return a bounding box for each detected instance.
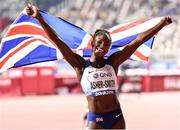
[81,60,117,96]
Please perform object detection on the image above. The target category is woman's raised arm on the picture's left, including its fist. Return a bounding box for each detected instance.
[26,4,85,70]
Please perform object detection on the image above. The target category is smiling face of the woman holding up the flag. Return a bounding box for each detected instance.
[92,34,111,57]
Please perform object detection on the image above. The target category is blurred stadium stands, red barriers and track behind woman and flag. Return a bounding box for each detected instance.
[0,0,180,129]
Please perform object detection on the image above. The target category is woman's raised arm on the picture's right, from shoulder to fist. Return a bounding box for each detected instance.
[109,16,172,72]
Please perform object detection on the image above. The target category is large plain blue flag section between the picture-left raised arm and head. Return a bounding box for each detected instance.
[41,12,86,49]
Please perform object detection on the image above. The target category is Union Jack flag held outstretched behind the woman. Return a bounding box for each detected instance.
[0,10,161,72]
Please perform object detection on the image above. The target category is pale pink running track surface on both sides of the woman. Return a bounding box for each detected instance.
[0,92,180,129]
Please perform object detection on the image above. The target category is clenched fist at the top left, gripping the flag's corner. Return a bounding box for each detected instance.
[26,4,40,19]
